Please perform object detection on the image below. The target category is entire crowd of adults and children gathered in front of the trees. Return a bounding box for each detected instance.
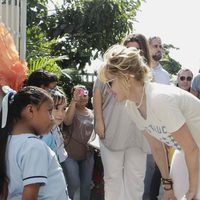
[0,20,200,200]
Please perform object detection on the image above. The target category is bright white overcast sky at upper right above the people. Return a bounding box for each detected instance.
[134,0,200,74]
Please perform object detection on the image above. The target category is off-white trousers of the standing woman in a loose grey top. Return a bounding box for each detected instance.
[100,142,146,200]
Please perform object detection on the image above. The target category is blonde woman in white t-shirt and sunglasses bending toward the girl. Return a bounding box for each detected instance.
[98,45,200,200]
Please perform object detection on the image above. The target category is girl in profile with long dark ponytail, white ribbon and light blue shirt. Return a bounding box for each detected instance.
[0,86,68,200]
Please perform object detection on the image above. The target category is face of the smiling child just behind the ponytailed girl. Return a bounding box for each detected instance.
[52,101,67,125]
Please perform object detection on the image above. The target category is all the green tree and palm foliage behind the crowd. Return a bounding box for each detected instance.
[27,0,181,95]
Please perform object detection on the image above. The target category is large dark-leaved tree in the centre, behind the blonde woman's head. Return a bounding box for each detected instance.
[47,0,141,73]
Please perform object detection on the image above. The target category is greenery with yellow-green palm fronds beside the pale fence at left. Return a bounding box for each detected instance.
[26,0,67,76]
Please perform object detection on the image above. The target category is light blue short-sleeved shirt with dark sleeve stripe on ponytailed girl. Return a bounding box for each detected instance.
[6,134,69,200]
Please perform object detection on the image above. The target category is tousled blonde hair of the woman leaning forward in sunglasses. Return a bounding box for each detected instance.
[98,45,150,82]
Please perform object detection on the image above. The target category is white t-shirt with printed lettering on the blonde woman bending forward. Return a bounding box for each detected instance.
[127,83,200,149]
